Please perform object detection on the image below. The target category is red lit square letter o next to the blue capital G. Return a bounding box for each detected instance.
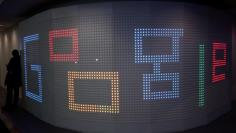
[49,28,79,62]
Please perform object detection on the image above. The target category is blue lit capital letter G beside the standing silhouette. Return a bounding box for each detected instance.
[24,34,43,102]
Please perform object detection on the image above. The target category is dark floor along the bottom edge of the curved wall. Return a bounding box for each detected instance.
[0,102,236,133]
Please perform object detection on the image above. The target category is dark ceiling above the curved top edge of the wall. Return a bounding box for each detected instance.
[0,0,236,31]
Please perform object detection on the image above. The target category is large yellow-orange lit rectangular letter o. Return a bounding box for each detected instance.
[68,71,119,113]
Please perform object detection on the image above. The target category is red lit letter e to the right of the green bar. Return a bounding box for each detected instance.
[212,43,227,83]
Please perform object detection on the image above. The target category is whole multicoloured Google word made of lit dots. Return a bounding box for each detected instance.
[23,28,228,114]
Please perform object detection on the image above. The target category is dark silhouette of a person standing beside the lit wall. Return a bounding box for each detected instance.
[3,50,22,111]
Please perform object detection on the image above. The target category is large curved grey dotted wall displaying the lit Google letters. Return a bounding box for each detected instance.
[19,2,231,133]
